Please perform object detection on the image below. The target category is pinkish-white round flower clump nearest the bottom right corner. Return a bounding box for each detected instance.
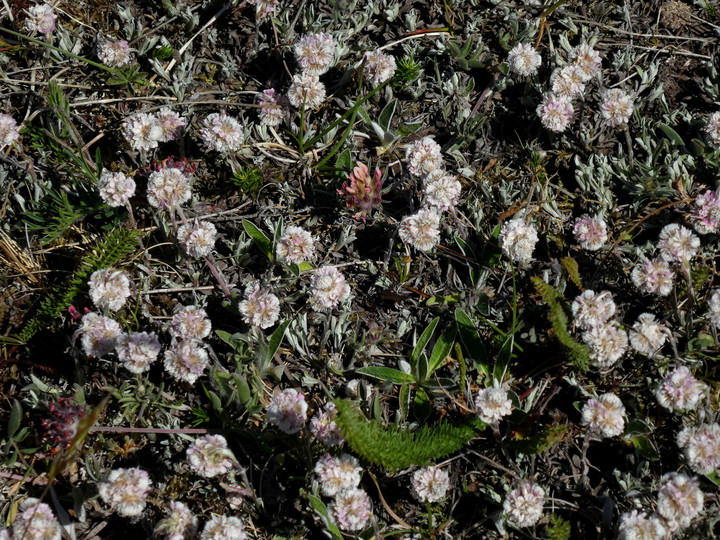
[657,472,705,531]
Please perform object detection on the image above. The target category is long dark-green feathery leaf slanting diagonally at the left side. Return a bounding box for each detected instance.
[18,227,142,343]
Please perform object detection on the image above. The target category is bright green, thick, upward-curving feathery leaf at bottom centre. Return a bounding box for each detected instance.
[335,399,485,470]
